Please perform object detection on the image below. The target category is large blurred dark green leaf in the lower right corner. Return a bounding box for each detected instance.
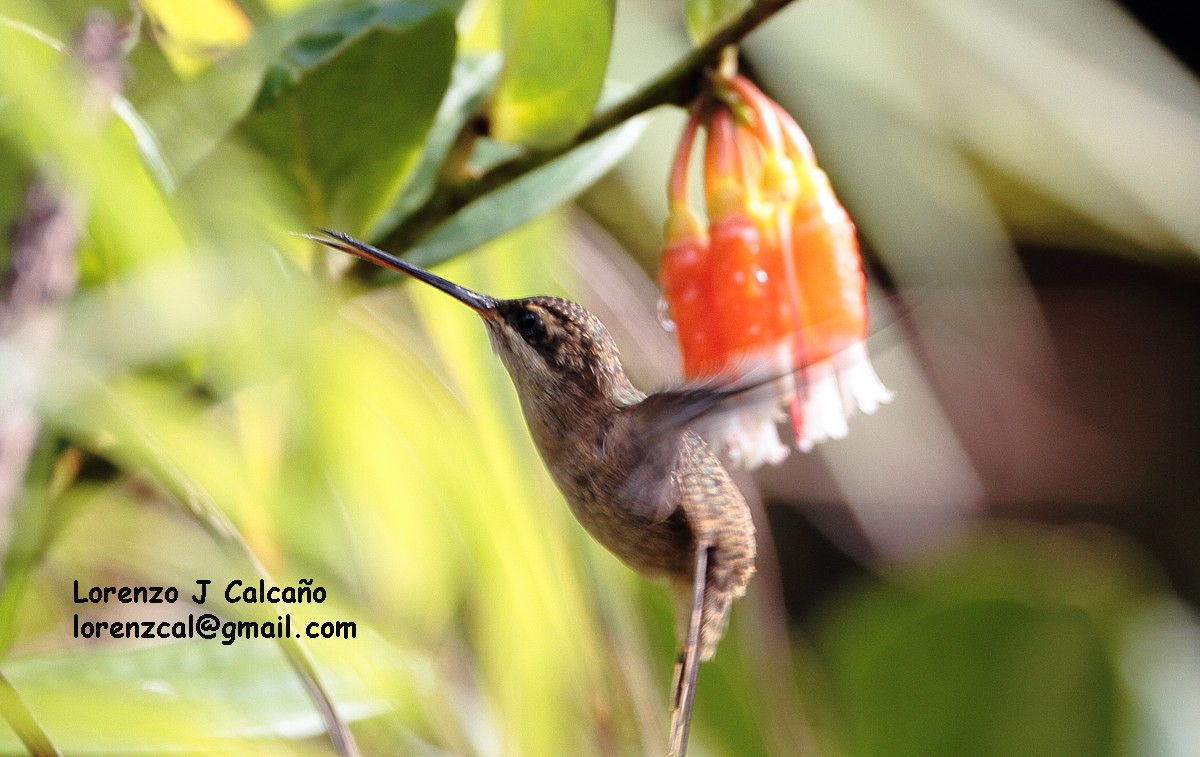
[822,537,1142,757]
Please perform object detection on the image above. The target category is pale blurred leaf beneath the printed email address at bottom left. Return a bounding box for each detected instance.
[0,638,393,755]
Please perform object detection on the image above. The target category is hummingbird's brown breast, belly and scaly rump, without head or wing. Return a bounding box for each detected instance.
[514,373,756,660]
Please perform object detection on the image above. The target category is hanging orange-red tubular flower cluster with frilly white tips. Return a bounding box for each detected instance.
[660,76,892,468]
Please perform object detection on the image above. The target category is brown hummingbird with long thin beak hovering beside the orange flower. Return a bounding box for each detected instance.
[302,229,756,757]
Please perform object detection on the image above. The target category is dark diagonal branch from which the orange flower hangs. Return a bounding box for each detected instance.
[380,0,793,250]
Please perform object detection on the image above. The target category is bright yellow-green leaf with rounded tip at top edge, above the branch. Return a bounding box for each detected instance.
[490,0,613,148]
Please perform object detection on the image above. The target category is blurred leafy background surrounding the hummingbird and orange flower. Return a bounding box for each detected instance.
[0,0,1200,757]
